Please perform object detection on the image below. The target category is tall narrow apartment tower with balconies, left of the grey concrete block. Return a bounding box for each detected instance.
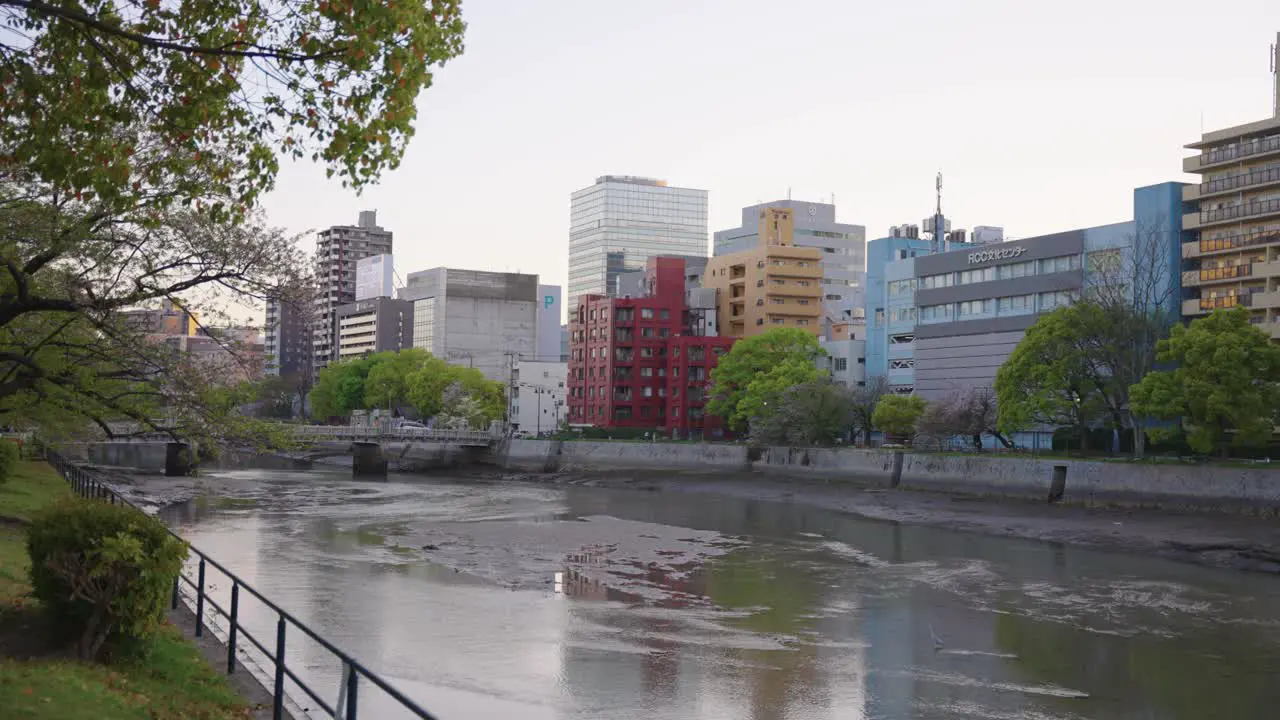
[311,210,392,372]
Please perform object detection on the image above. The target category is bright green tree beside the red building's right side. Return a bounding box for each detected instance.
[707,328,824,432]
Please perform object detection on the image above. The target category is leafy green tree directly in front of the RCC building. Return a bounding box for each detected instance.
[996,304,1102,448]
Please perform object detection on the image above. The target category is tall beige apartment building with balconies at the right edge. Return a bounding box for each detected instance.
[1181,35,1280,330]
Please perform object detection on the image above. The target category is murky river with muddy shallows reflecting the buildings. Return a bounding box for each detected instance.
[164,470,1280,720]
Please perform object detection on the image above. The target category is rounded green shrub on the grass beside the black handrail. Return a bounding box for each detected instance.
[27,498,187,660]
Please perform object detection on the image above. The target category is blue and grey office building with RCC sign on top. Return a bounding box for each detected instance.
[867,182,1183,447]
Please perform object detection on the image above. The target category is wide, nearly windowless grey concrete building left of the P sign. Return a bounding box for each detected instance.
[399,268,541,384]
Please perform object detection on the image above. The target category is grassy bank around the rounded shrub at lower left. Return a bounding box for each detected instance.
[0,462,250,720]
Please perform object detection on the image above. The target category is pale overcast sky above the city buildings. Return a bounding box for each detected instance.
[252,0,1280,319]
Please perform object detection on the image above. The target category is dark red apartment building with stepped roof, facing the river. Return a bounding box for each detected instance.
[568,258,733,438]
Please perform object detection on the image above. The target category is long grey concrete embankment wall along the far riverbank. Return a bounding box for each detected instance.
[497,439,1280,514]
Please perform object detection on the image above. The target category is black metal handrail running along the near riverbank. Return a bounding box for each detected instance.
[47,451,438,720]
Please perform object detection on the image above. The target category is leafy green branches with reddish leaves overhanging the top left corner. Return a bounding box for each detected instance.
[0,0,465,213]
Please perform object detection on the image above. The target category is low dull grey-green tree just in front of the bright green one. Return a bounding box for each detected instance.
[751,379,852,446]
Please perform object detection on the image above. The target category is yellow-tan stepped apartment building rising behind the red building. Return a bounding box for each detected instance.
[703,208,823,337]
